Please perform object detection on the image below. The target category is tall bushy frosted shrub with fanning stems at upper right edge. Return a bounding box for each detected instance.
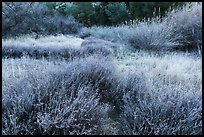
[129,3,202,51]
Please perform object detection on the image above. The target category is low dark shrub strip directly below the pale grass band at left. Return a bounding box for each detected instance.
[2,45,80,59]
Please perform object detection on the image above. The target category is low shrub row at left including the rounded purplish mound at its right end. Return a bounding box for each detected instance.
[2,38,117,59]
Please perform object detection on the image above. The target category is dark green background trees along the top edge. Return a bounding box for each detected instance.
[49,2,184,26]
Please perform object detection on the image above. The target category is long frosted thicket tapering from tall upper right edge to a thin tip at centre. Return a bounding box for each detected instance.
[80,3,202,53]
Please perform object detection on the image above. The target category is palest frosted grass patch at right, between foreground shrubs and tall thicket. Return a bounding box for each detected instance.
[114,51,202,85]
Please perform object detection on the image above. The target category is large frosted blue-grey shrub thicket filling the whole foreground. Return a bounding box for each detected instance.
[2,55,202,135]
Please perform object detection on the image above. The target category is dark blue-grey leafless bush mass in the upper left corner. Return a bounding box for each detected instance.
[2,2,81,38]
